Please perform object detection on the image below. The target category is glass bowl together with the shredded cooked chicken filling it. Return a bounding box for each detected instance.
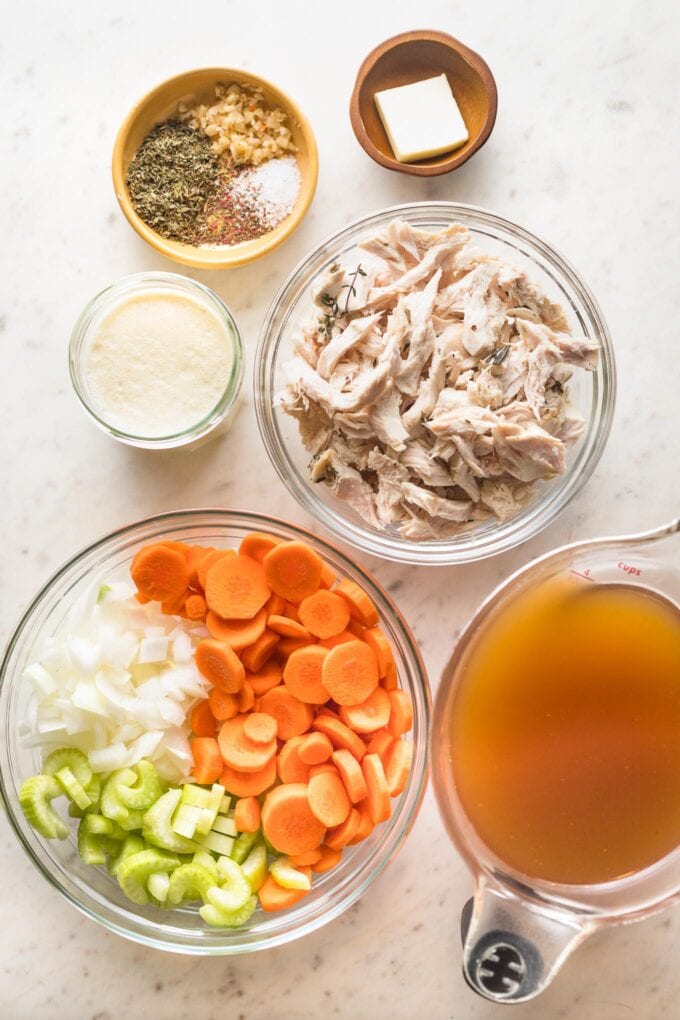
[255,202,616,565]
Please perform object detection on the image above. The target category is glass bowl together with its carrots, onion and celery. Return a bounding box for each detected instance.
[0,510,430,956]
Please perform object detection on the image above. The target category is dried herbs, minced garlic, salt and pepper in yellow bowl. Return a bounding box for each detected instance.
[126,83,302,247]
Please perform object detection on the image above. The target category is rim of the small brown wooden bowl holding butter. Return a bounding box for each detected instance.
[350,29,499,177]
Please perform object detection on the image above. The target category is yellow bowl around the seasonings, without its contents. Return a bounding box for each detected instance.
[111,67,319,269]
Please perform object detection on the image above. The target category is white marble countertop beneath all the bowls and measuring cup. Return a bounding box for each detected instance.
[0,0,680,1020]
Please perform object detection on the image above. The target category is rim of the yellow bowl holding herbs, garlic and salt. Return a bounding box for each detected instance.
[111,67,319,270]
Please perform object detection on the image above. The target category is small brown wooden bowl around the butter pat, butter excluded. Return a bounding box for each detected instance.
[350,31,498,177]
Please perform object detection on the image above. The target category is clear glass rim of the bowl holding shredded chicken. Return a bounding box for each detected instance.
[253,201,617,566]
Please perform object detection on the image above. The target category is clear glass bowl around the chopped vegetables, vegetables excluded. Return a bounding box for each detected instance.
[0,510,430,956]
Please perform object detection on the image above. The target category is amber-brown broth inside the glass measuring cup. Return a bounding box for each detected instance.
[450,577,680,884]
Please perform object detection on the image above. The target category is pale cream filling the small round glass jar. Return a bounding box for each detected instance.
[84,289,233,439]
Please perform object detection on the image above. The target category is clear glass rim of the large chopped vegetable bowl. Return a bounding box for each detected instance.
[0,507,432,956]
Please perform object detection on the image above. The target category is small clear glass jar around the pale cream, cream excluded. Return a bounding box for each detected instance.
[68,272,244,450]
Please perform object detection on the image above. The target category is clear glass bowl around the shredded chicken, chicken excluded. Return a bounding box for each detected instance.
[254,202,616,565]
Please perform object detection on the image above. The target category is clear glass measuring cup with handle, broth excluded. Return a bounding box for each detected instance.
[432,518,680,1003]
